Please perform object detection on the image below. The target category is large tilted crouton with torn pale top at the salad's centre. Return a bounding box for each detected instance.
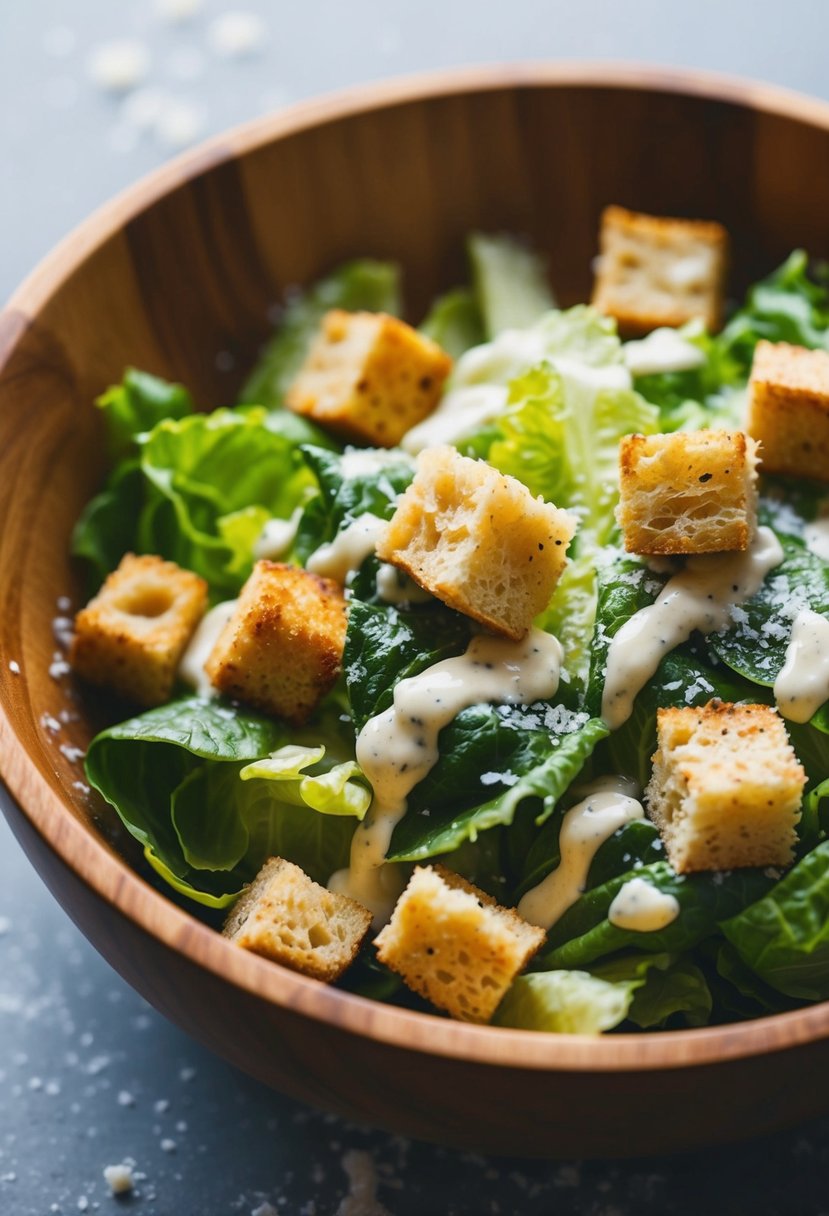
[377,447,575,641]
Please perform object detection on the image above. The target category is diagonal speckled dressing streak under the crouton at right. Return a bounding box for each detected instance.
[602,528,783,731]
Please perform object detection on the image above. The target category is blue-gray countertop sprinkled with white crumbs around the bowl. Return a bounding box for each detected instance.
[0,0,829,1216]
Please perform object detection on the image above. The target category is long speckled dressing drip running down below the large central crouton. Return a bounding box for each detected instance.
[328,629,562,924]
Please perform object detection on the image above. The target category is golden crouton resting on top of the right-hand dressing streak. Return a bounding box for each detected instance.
[616,430,757,553]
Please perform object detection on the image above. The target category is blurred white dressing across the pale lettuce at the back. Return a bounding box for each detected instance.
[402,320,632,452]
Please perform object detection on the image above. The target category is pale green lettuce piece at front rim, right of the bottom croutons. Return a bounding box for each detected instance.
[492,970,644,1035]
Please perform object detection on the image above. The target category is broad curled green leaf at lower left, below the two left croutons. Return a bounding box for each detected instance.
[86,698,359,907]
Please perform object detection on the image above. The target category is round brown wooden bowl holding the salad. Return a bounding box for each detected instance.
[0,64,829,1155]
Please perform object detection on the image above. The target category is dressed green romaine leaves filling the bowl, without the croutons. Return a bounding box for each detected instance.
[66,229,829,1034]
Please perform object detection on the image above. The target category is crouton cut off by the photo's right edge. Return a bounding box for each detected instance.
[746,342,829,482]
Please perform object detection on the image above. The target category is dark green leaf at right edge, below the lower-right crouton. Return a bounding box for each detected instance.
[722,840,829,1001]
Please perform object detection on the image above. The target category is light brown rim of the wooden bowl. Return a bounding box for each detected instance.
[0,61,829,1073]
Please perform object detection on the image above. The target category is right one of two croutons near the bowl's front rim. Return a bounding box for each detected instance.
[376,866,545,1021]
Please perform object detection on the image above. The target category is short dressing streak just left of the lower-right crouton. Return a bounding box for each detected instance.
[518,778,644,929]
